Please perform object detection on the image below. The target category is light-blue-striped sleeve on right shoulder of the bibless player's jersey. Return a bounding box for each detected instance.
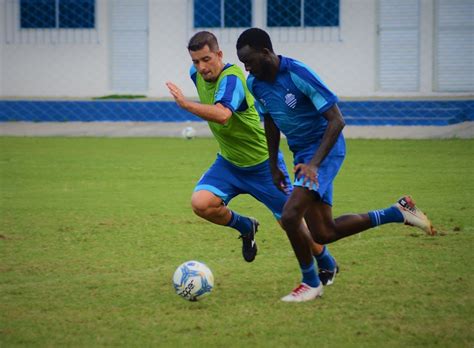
[290,61,338,113]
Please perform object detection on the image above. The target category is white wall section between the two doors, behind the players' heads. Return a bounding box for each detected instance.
[150,0,377,96]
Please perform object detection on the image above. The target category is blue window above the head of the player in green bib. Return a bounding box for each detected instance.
[194,0,252,28]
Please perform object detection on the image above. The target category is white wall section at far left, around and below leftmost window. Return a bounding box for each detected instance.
[0,0,109,97]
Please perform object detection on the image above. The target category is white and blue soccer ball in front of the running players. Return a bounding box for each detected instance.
[173,261,214,301]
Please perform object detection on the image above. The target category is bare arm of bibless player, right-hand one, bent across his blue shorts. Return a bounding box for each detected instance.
[293,104,346,188]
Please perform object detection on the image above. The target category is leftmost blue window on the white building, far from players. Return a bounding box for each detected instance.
[20,0,95,29]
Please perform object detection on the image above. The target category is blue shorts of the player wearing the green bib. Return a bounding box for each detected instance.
[194,153,292,219]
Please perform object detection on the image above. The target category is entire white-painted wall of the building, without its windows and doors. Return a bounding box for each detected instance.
[0,0,470,98]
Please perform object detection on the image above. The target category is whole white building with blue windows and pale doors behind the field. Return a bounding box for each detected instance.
[0,0,474,98]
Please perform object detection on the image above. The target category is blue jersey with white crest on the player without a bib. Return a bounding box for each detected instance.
[247,56,345,155]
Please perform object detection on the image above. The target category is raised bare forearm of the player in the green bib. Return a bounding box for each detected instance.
[166,82,232,124]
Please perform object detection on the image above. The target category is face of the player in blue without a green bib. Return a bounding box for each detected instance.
[237,45,274,81]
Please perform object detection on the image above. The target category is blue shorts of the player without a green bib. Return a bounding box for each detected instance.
[293,146,345,206]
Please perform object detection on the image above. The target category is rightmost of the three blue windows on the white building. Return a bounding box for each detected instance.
[267,0,339,27]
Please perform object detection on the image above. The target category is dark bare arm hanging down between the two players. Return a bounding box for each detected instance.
[263,114,287,192]
